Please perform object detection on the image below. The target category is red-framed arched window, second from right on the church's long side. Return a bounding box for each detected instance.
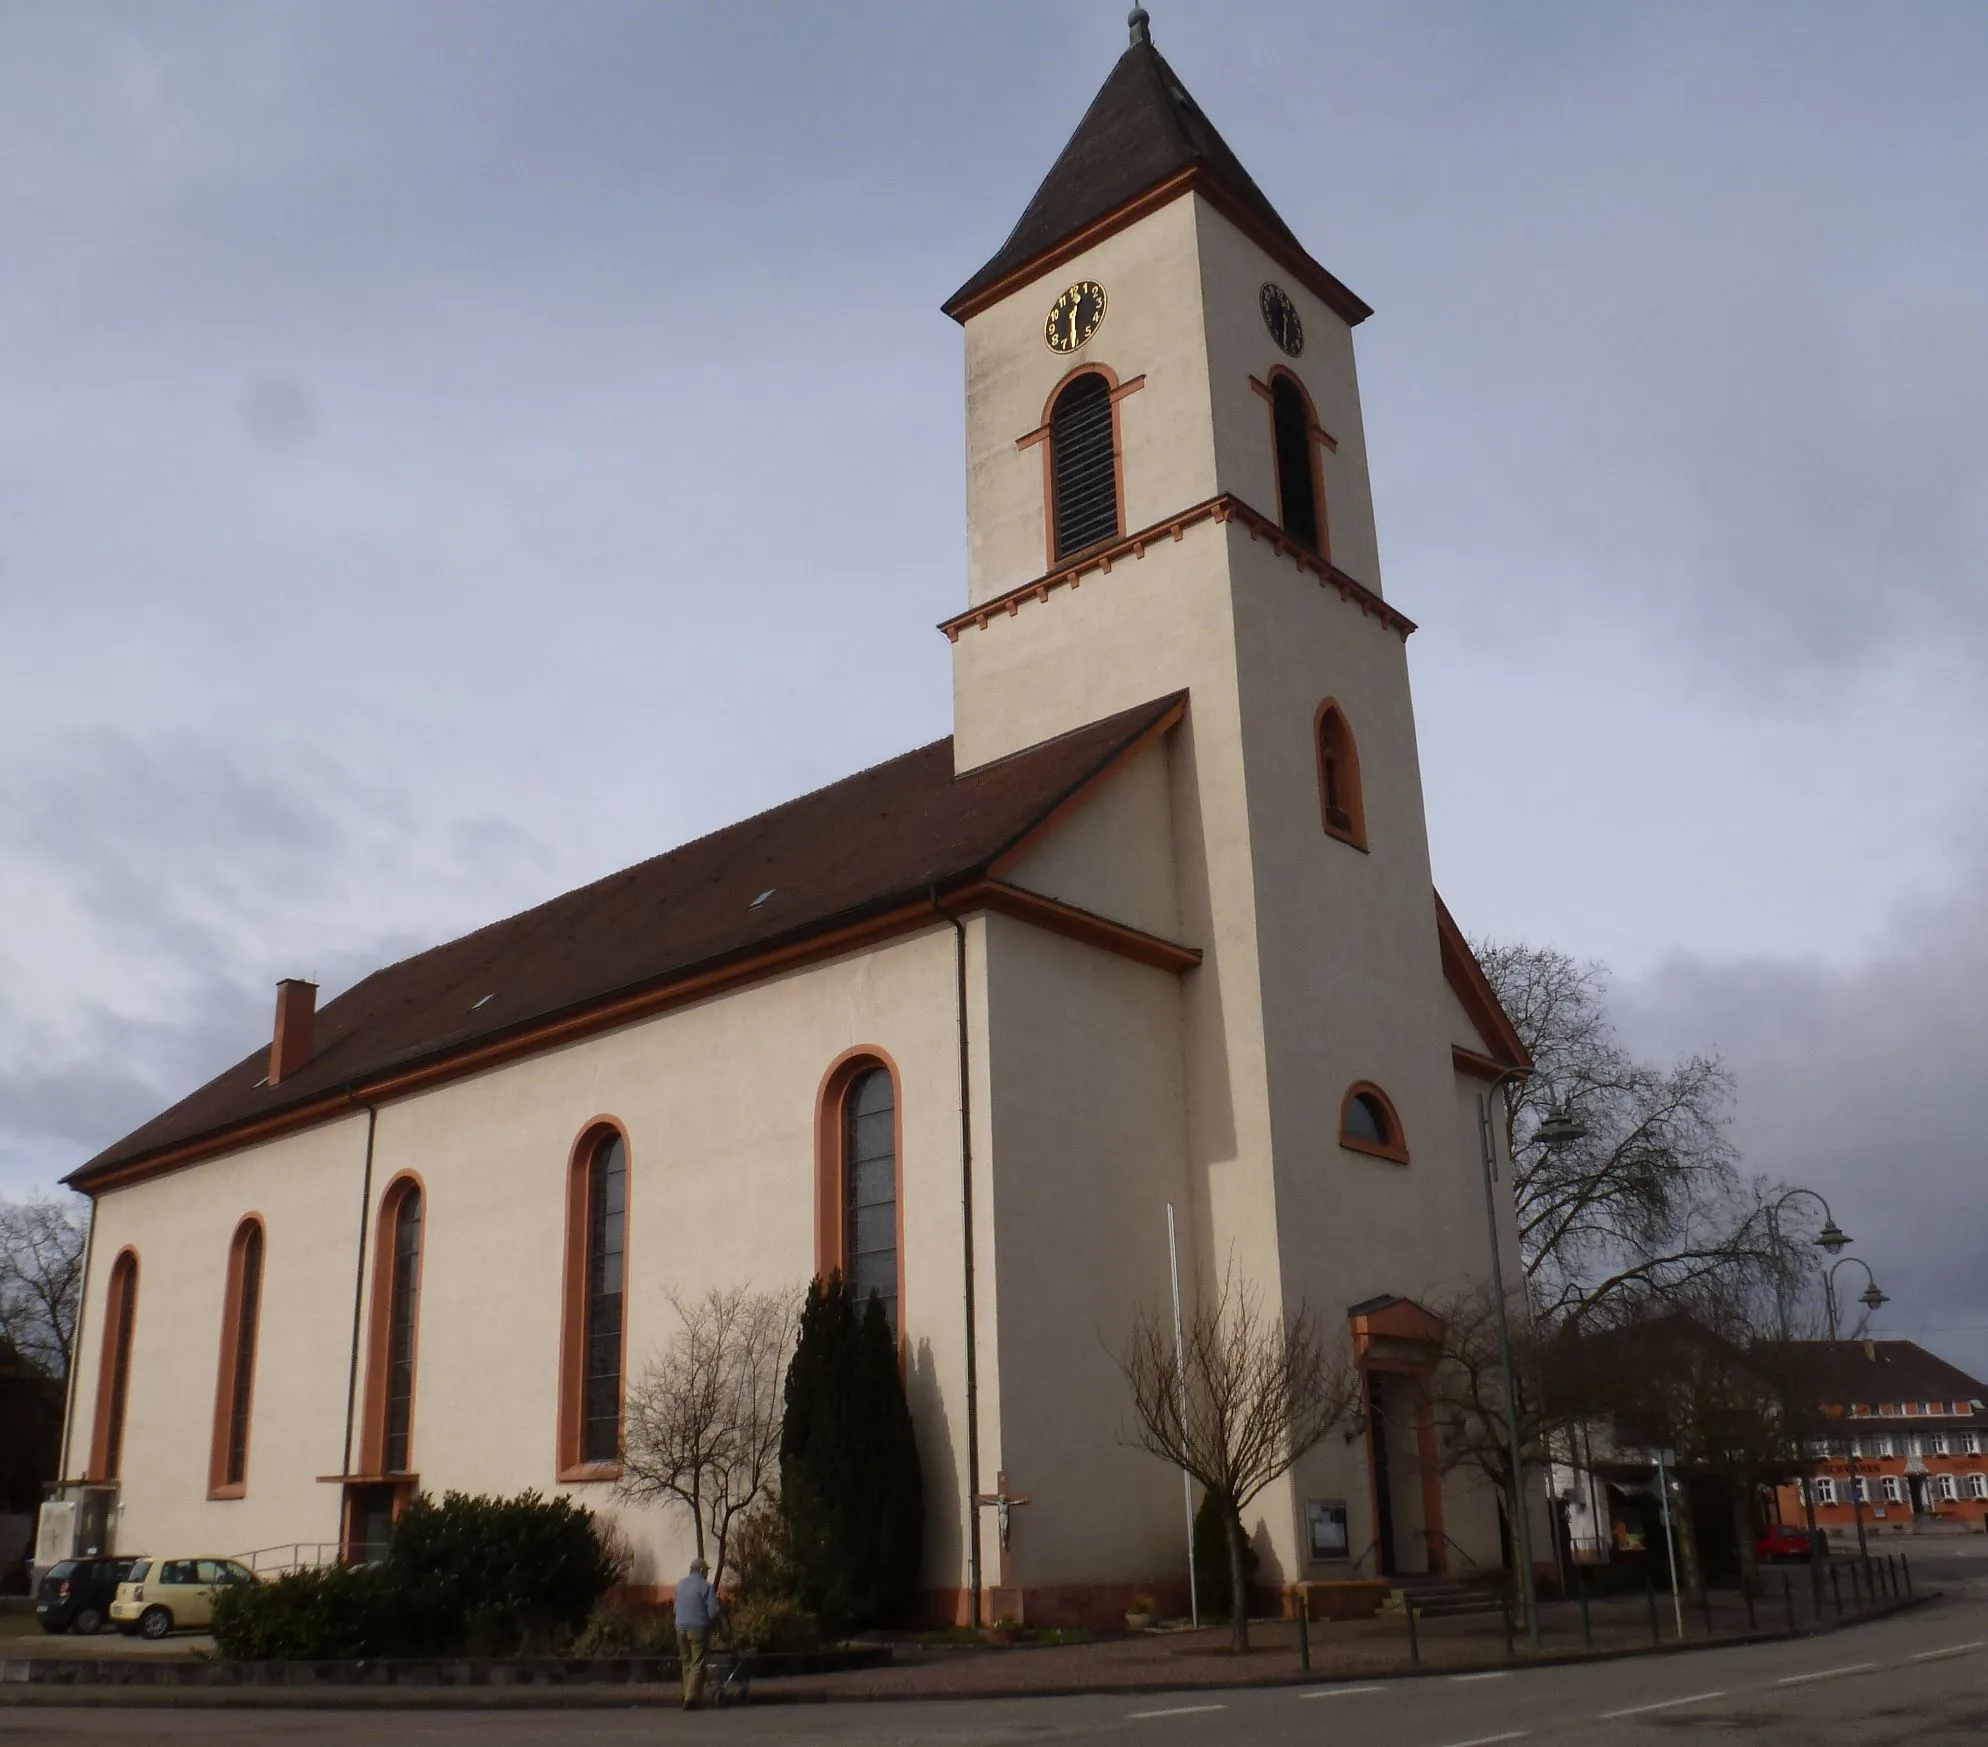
[559,1127,628,1481]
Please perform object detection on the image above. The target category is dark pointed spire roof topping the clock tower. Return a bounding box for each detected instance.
[944,29,1374,322]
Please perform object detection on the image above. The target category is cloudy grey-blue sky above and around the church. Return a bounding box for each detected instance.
[0,0,1988,1371]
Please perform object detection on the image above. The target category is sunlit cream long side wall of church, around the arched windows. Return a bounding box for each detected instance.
[74,920,992,1588]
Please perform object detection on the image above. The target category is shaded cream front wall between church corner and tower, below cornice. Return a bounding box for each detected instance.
[988,916,1195,1588]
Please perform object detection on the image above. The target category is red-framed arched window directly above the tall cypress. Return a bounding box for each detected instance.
[815,1049,903,1334]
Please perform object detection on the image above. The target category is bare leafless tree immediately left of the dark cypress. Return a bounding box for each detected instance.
[620,1286,797,1584]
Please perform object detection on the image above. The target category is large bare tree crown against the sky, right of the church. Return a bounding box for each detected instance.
[1475,942,1813,1326]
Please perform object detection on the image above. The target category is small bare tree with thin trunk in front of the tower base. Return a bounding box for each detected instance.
[1119,1270,1362,1650]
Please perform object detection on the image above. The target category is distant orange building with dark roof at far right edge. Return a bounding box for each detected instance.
[1775,1340,1988,1538]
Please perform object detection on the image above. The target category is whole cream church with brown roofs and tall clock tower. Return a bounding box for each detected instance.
[62,10,1525,1624]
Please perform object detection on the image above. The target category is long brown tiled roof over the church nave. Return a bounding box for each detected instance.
[68,696,1181,1189]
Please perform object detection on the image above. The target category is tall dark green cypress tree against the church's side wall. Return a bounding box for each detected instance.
[779,1274,924,1630]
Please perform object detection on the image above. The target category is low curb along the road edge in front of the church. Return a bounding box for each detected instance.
[0,1590,1944,1711]
